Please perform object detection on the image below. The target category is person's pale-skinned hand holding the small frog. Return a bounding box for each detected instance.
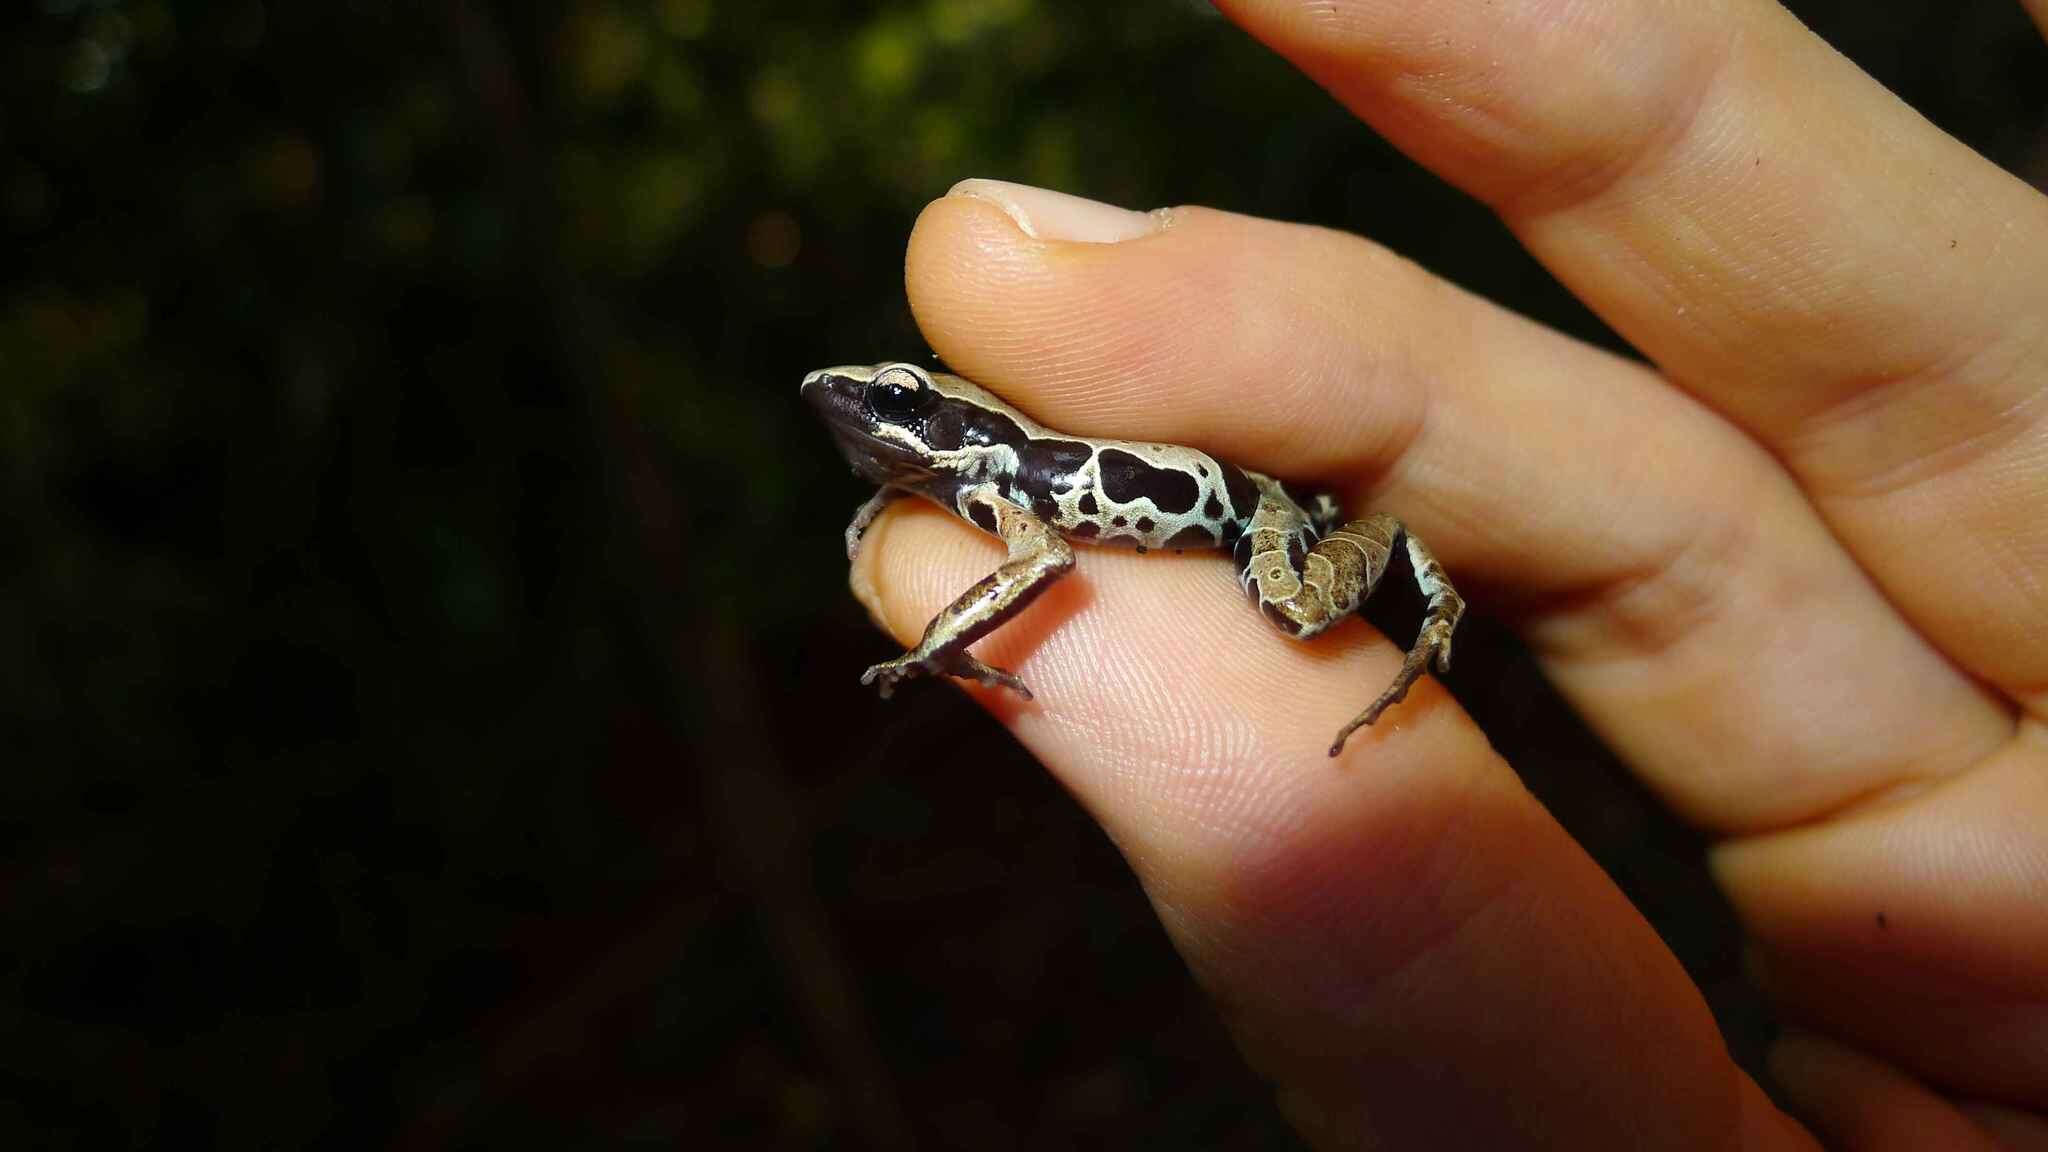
[854,0,2048,1150]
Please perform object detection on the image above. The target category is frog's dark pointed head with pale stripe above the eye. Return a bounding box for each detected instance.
[803,363,942,486]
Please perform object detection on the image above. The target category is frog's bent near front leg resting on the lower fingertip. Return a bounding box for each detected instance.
[860,484,1073,699]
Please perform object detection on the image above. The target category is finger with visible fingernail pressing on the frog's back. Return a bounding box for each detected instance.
[907,184,2011,832]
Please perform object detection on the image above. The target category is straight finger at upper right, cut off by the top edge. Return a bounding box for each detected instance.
[1223,0,2048,707]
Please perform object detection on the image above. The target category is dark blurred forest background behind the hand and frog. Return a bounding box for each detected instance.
[0,0,2048,1150]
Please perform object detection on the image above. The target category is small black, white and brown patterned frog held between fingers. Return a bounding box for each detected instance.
[801,363,1464,756]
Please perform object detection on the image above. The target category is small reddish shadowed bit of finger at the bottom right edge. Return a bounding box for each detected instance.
[1772,1033,1999,1152]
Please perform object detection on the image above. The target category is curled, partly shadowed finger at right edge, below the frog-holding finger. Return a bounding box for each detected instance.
[1714,722,2048,1109]
